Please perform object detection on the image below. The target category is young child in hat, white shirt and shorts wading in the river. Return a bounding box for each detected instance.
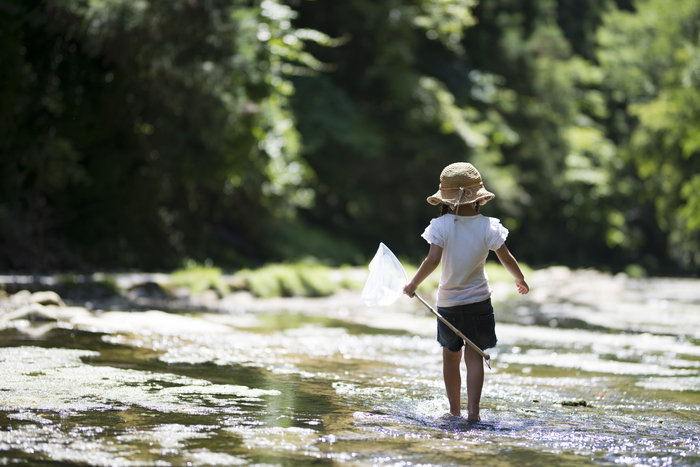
[403,162,530,421]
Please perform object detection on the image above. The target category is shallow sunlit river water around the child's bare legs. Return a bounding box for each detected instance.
[0,269,700,467]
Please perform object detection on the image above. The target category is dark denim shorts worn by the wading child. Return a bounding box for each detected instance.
[438,298,498,352]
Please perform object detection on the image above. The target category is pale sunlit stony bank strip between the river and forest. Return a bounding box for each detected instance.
[0,267,700,339]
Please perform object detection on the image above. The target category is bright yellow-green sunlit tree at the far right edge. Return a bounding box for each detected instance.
[598,0,700,269]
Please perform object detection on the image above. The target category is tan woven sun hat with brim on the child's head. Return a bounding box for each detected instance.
[428,162,496,209]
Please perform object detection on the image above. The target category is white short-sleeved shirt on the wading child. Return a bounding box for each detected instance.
[422,214,508,307]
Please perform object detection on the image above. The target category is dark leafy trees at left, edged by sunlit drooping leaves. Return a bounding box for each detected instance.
[0,0,328,268]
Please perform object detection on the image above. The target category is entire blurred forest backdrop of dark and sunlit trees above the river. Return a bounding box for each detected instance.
[0,0,700,275]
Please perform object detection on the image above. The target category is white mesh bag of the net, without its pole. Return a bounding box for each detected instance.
[362,243,408,306]
